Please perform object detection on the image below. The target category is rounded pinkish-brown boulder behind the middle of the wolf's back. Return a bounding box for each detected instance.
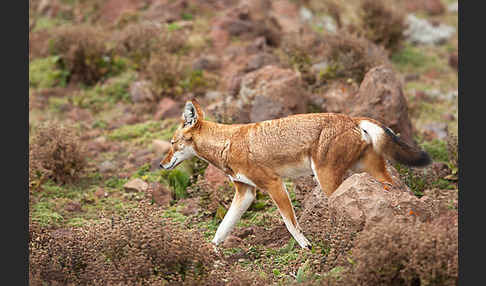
[239,65,307,122]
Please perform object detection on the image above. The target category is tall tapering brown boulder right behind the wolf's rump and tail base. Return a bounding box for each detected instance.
[346,66,413,143]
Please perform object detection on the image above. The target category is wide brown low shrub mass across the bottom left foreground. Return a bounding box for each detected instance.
[29,201,270,285]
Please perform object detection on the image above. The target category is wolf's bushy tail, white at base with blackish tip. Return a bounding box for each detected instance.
[357,118,431,167]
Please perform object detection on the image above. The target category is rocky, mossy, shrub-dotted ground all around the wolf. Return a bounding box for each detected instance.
[29,0,459,285]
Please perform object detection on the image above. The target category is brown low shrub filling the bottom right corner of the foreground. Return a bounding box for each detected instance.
[341,211,458,285]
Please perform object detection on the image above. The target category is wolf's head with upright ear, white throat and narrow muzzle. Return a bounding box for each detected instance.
[160,99,204,170]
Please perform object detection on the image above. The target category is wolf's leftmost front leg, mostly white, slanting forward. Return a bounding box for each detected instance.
[212,182,256,245]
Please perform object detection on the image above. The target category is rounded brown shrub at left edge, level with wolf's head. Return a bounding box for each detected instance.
[29,122,86,184]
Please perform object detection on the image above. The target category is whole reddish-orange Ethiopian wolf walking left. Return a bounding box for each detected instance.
[160,100,430,248]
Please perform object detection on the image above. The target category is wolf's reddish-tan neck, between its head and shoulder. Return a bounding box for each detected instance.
[193,121,236,171]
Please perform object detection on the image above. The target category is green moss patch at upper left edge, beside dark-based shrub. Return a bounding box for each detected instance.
[29,56,69,88]
